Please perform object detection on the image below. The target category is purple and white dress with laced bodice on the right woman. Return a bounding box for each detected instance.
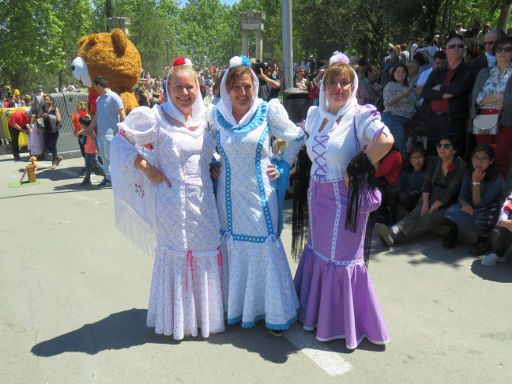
[295,103,389,349]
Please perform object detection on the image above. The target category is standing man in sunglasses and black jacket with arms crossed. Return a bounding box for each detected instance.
[421,36,475,155]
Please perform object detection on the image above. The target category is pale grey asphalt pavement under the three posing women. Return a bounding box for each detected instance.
[0,156,512,384]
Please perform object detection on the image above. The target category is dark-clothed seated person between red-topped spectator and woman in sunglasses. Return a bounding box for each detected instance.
[389,146,427,224]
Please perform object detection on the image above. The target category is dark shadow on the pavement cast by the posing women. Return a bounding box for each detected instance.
[31,308,298,364]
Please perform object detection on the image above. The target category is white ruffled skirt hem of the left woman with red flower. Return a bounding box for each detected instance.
[146,247,225,340]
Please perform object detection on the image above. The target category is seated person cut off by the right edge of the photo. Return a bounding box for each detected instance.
[482,193,512,267]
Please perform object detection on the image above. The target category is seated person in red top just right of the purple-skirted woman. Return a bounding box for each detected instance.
[370,146,404,224]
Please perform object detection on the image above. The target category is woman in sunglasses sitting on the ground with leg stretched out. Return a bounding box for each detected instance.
[376,135,466,246]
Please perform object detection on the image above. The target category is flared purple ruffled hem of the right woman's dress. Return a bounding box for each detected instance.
[295,247,389,349]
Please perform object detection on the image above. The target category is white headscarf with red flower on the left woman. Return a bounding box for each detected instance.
[162,57,205,128]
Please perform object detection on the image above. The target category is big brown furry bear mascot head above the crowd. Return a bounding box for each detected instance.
[71,28,142,114]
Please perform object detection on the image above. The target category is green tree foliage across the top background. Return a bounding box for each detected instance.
[0,0,512,90]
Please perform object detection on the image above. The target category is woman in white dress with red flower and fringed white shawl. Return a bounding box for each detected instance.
[112,58,224,340]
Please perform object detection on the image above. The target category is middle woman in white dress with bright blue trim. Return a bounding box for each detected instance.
[209,56,303,333]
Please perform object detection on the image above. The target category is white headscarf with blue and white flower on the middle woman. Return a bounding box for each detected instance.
[217,56,263,127]
